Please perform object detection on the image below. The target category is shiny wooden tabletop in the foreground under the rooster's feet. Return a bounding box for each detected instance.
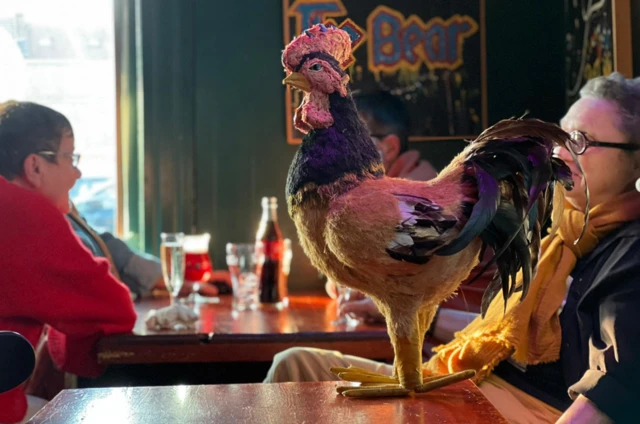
[29,380,507,424]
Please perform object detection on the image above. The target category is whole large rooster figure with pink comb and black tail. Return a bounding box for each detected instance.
[282,25,572,397]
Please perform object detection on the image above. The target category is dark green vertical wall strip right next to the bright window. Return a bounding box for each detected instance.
[141,0,197,252]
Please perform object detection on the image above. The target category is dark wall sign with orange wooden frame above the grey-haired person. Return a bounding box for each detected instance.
[564,0,632,107]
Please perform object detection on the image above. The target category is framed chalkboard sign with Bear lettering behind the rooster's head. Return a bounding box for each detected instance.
[283,0,487,144]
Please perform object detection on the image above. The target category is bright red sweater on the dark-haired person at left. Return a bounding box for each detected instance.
[0,177,136,423]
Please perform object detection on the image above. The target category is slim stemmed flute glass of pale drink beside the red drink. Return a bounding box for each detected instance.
[160,233,185,305]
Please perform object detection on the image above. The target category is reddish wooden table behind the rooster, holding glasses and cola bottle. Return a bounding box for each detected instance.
[98,295,393,364]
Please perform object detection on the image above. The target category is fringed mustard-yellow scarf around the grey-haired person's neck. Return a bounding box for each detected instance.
[424,191,640,382]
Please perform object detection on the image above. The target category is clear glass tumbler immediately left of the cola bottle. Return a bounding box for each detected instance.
[226,243,260,311]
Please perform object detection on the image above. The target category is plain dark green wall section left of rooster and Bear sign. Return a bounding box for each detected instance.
[195,0,317,288]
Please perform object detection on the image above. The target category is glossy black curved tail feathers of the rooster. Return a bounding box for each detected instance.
[436,119,573,316]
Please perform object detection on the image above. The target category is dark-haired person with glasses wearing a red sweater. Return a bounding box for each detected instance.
[0,102,136,423]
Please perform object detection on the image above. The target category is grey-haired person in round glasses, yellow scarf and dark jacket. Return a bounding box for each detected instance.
[265,73,640,423]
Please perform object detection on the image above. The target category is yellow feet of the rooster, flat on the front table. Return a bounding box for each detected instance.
[331,367,476,398]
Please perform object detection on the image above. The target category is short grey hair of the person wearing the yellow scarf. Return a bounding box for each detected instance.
[580,72,640,144]
